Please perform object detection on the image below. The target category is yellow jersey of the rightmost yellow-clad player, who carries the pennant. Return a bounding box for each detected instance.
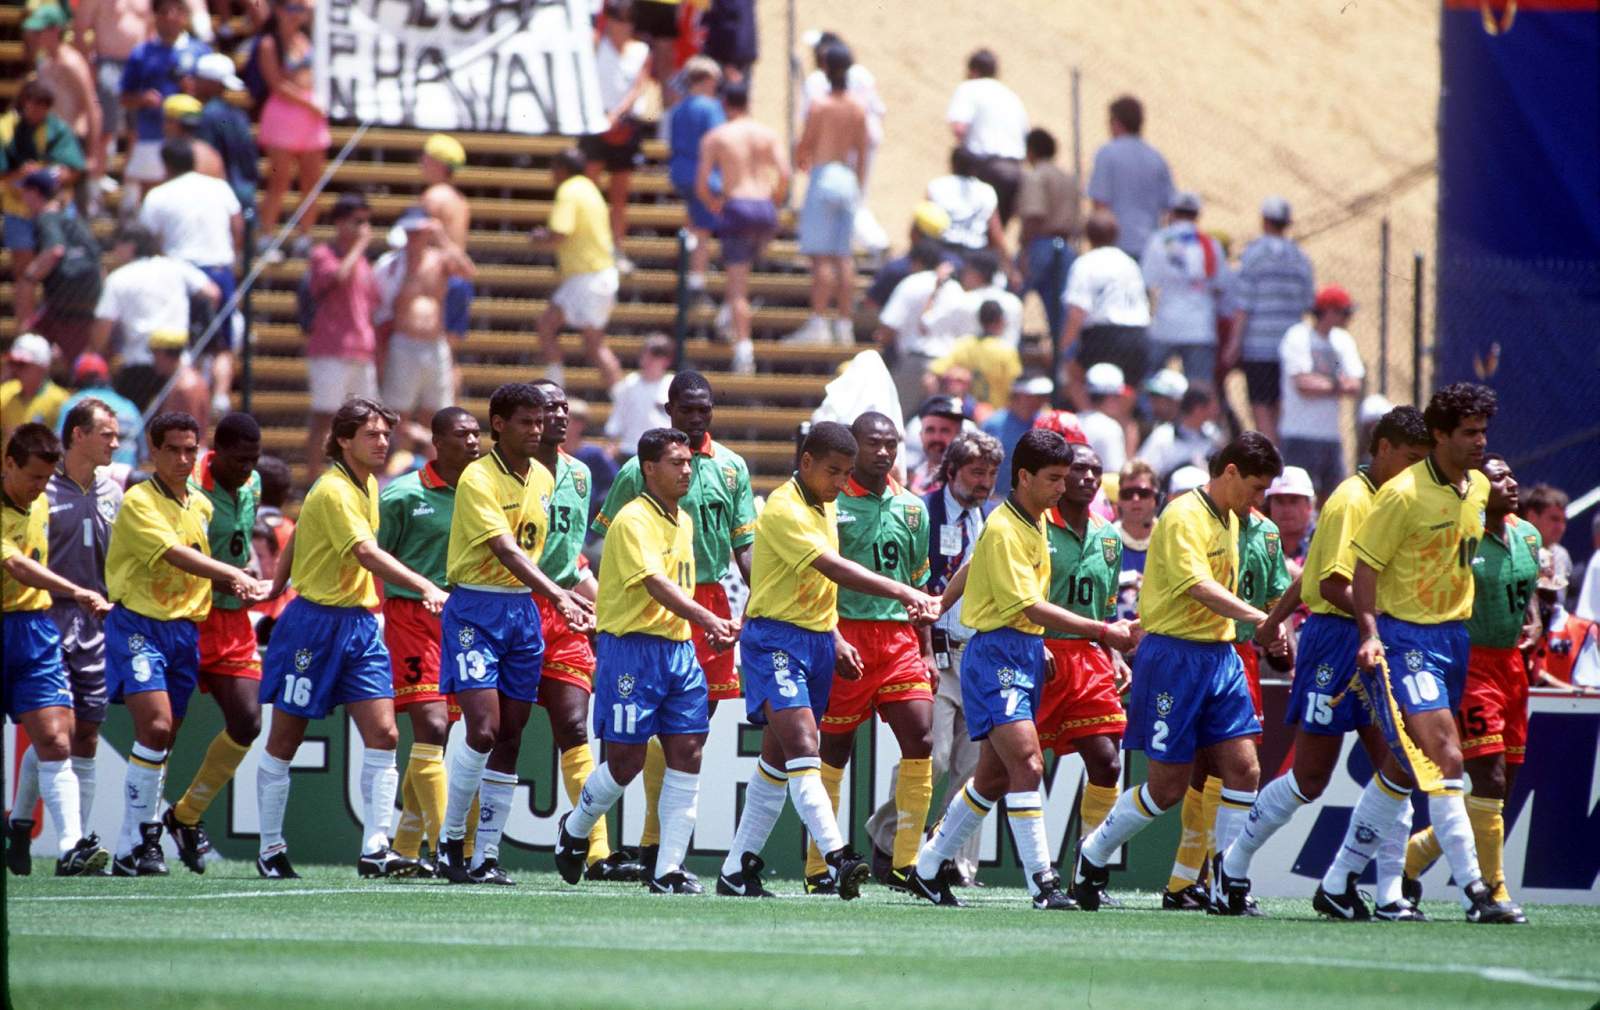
[1356,456,1490,624]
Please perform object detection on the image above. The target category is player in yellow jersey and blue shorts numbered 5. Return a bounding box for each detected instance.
[717,421,939,901]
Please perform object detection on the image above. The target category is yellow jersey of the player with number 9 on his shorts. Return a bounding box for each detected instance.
[106,477,211,623]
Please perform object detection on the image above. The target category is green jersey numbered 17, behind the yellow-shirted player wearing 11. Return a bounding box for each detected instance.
[594,435,755,584]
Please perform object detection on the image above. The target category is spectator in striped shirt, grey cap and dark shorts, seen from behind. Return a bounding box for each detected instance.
[1219,197,1317,442]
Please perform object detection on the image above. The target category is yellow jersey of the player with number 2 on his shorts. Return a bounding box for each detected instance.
[1139,488,1238,642]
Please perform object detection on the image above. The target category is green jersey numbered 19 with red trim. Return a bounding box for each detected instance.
[837,477,928,621]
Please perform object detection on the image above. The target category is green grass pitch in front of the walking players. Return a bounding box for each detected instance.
[5,860,1600,1010]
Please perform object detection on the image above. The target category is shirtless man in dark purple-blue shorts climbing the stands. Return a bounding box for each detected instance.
[694,80,792,375]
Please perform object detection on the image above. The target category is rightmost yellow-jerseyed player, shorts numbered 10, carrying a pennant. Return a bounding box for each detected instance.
[1344,383,1517,922]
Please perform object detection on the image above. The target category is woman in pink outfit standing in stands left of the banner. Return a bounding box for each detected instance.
[256,0,333,259]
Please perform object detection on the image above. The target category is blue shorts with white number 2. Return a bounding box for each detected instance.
[1122,635,1261,765]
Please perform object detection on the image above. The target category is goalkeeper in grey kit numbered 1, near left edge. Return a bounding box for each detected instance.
[6,399,122,876]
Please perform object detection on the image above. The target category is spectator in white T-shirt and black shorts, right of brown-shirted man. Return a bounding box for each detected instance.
[1061,208,1150,403]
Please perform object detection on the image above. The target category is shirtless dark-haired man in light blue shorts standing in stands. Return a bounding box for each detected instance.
[786,42,870,346]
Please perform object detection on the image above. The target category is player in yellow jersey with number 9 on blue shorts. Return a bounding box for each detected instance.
[106,411,267,877]
